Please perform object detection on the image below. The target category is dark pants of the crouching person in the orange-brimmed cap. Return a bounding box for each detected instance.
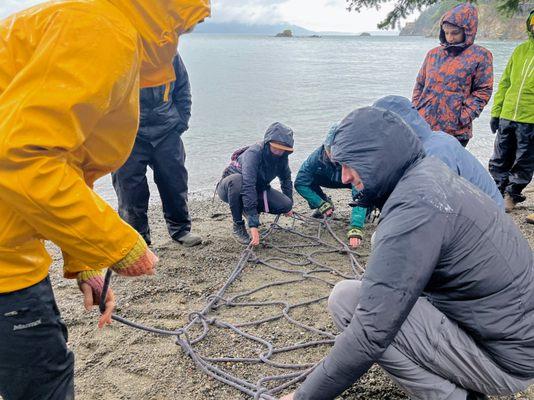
[217,174,293,222]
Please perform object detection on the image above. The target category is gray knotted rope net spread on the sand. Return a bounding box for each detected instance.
[100,213,364,400]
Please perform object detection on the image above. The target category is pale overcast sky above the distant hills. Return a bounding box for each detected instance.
[0,0,412,32]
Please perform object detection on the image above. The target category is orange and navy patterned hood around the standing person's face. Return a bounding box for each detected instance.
[439,3,478,49]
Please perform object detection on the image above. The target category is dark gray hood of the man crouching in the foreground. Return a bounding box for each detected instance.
[332,107,424,208]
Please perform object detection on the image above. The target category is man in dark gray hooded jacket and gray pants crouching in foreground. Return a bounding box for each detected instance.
[283,107,534,400]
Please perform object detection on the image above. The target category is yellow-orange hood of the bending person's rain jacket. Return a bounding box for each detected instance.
[108,0,210,87]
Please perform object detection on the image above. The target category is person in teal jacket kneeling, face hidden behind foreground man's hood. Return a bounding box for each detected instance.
[295,122,367,247]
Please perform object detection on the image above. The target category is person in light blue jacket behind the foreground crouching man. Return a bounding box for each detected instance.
[373,96,504,211]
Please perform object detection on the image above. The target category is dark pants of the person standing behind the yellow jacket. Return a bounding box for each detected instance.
[112,133,191,243]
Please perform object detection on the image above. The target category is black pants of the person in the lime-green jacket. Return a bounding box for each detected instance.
[489,119,534,203]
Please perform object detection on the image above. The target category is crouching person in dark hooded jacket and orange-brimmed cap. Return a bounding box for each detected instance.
[217,122,293,246]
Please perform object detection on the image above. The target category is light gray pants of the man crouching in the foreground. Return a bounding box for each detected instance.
[328,280,534,400]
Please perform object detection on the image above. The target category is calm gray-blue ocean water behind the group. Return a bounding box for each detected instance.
[96,34,518,204]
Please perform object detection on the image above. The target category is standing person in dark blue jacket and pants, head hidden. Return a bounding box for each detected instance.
[112,55,202,247]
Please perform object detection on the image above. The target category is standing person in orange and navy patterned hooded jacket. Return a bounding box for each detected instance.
[412,4,493,147]
